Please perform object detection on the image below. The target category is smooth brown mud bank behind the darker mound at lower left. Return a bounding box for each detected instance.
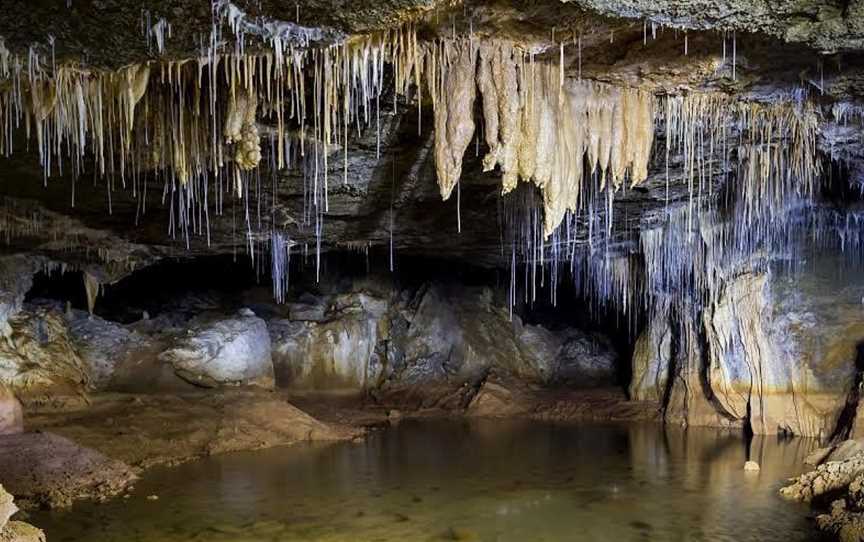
[23,390,361,479]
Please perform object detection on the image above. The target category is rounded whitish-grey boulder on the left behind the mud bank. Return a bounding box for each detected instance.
[159,309,274,388]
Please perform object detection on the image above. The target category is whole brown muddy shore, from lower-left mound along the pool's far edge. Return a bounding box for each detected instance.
[6,382,659,508]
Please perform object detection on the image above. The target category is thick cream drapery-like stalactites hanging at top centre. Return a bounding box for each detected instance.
[428,39,655,237]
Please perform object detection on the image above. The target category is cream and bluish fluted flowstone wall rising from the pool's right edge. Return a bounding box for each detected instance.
[630,257,864,438]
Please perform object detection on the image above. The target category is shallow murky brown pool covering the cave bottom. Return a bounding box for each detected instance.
[31,421,815,542]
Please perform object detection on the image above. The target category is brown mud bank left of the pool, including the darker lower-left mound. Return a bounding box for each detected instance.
[0,390,363,507]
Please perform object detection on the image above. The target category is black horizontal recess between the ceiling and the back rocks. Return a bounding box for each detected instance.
[26,249,634,396]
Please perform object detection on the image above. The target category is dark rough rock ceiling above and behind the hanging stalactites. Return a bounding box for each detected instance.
[0,0,864,281]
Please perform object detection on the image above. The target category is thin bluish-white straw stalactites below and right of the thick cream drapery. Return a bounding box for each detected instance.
[496,82,820,313]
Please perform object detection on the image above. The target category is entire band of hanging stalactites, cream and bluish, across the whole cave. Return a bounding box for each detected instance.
[0,17,832,306]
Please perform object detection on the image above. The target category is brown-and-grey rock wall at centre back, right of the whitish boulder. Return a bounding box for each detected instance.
[269,284,616,390]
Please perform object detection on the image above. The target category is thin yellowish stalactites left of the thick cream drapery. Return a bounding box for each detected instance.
[0,18,419,226]
